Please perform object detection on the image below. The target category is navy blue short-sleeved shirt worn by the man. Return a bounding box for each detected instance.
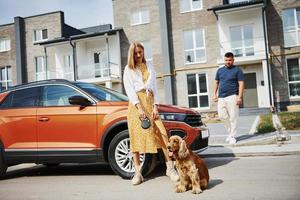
[215,65,244,98]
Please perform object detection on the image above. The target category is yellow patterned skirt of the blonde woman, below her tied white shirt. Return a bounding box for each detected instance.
[127,91,168,153]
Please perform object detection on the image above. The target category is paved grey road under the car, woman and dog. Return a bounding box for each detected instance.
[0,155,300,200]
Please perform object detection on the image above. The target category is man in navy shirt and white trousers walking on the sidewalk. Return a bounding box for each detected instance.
[213,52,244,144]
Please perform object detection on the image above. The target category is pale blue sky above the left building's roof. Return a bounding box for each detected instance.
[0,0,113,28]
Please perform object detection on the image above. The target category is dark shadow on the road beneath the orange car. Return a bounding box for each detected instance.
[2,163,115,180]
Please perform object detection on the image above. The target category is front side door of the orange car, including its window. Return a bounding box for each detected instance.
[37,85,98,162]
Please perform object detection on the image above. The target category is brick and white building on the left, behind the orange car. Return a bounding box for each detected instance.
[0,11,122,91]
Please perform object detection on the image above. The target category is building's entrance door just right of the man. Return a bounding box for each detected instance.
[242,73,258,108]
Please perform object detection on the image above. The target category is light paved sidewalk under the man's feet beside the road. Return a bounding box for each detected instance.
[199,115,300,157]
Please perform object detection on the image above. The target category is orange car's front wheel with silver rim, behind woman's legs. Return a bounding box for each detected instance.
[108,130,155,179]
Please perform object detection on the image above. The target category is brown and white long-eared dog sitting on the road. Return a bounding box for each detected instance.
[167,135,209,194]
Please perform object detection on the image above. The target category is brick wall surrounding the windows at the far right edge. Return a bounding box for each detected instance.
[266,0,300,110]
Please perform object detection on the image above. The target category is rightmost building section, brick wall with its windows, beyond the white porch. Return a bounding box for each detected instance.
[266,0,300,110]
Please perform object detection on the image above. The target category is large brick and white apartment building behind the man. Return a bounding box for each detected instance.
[113,0,300,112]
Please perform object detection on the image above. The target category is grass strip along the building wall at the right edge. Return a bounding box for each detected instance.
[257,112,300,134]
